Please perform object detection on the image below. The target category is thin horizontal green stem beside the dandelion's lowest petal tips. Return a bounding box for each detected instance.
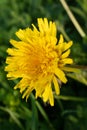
[54,95,87,102]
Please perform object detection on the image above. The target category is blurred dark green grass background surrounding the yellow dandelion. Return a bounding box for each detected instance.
[0,0,87,130]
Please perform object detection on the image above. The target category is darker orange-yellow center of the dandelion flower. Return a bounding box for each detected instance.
[27,46,58,78]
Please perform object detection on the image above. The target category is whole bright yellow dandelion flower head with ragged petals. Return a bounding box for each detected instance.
[5,18,73,106]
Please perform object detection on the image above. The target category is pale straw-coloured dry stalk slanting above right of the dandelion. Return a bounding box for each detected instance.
[60,0,86,37]
